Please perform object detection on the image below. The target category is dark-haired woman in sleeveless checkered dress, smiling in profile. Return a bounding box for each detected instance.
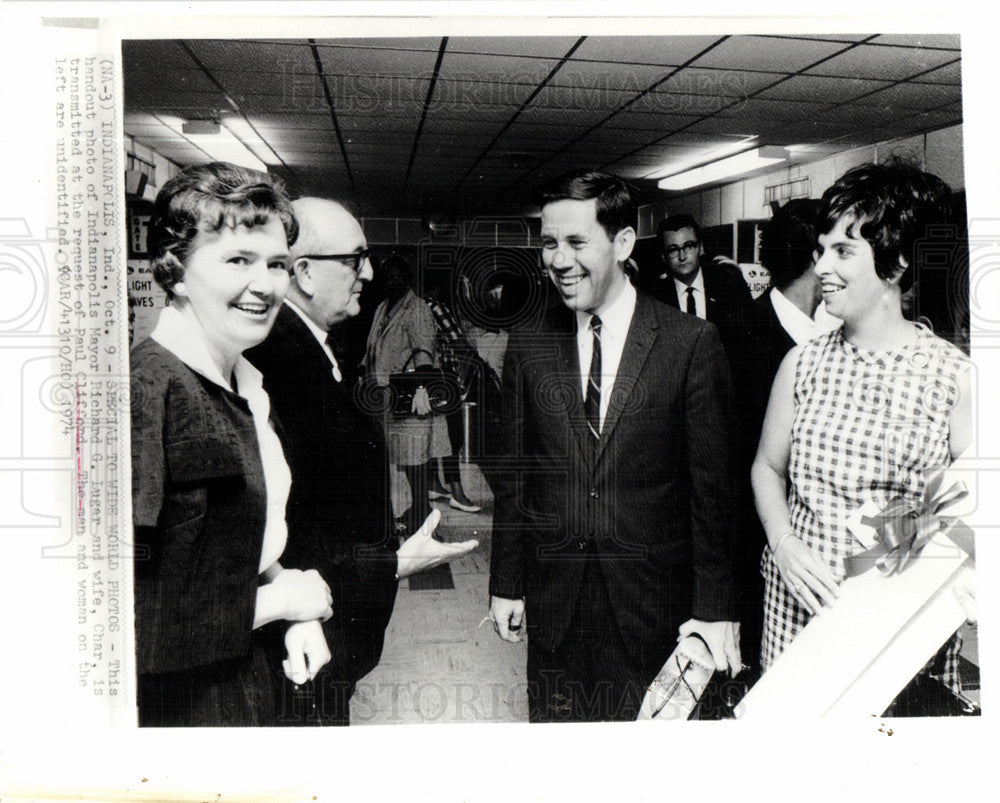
[752,162,971,687]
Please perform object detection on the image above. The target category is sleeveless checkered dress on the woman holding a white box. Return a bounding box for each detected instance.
[761,325,970,691]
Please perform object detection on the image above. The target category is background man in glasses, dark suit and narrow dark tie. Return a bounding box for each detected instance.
[642,214,753,359]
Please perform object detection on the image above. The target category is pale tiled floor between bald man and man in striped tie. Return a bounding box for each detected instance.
[351,458,528,725]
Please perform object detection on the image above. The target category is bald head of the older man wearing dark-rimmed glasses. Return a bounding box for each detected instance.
[288,198,372,331]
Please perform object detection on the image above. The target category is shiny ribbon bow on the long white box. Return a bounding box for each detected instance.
[844,467,975,577]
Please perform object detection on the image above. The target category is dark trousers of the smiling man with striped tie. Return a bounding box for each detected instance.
[527,559,670,722]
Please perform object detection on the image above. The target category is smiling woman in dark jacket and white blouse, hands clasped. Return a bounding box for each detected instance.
[131,163,331,726]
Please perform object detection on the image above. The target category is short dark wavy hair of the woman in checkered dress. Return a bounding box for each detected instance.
[817,158,951,292]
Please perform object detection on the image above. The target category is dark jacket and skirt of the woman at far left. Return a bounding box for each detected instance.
[131,340,278,725]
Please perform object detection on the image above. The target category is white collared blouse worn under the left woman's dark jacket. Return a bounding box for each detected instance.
[150,307,292,573]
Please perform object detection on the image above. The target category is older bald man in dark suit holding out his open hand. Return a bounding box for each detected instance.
[247,198,476,725]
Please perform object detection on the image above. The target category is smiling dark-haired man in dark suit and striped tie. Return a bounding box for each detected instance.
[490,171,741,722]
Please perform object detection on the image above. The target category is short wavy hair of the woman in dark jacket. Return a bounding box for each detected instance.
[148,162,299,298]
